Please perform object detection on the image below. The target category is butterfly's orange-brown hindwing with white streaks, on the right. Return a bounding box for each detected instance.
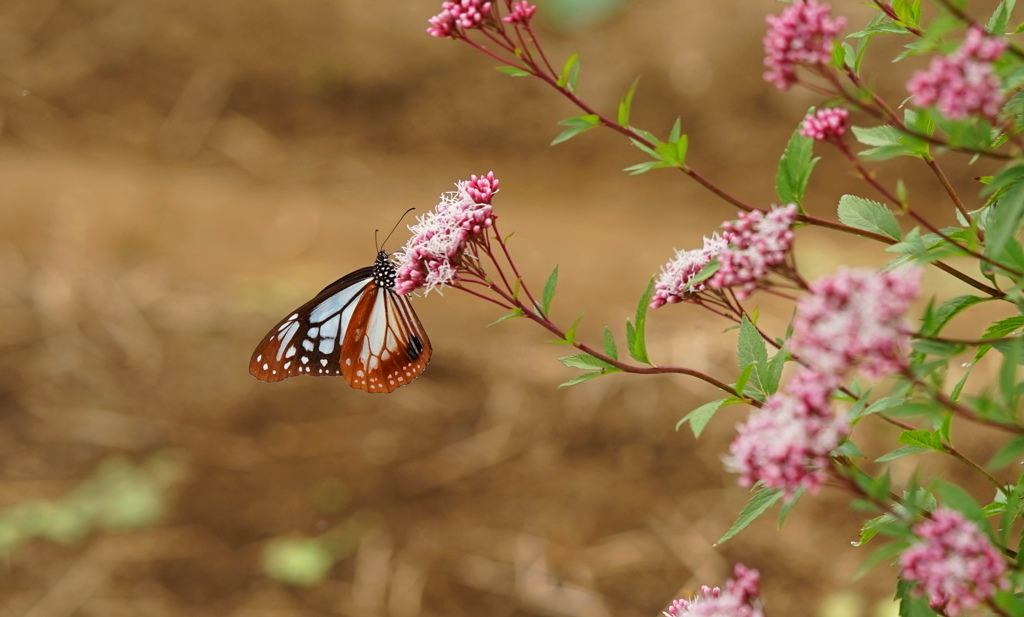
[341,283,431,392]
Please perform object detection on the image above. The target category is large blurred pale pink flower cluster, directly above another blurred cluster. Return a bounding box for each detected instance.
[790,268,921,379]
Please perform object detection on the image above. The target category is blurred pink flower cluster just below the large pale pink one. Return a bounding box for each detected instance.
[726,368,850,498]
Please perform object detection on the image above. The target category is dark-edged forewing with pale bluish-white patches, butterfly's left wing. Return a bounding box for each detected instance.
[249,266,376,384]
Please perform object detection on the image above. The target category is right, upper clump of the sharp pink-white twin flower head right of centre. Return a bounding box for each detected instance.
[708,204,797,299]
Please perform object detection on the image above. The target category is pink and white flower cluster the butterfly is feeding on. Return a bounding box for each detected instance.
[394,172,499,294]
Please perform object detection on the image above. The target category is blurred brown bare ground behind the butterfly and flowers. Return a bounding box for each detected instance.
[0,0,1007,617]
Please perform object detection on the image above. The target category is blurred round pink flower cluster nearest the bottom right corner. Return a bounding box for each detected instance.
[900,509,1010,617]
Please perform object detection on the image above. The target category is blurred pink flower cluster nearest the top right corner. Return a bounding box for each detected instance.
[906,28,1007,120]
